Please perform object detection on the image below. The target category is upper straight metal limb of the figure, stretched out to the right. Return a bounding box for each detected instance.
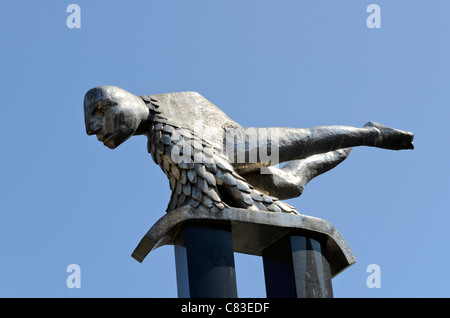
[226,122,414,174]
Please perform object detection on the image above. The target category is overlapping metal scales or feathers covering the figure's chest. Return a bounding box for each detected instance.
[141,95,299,214]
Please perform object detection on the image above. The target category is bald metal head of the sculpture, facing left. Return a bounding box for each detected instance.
[84,86,150,149]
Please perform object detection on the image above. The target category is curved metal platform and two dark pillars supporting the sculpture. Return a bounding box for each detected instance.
[132,206,355,298]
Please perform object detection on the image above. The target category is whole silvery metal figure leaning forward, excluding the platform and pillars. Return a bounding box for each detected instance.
[84,86,414,214]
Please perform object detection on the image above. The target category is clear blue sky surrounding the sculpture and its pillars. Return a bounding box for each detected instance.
[0,0,450,297]
